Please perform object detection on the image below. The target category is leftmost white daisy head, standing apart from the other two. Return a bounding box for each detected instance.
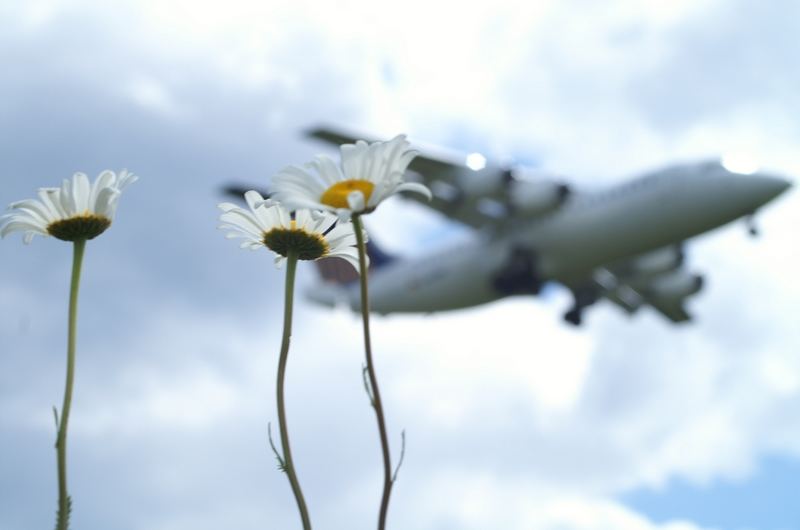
[0,170,138,243]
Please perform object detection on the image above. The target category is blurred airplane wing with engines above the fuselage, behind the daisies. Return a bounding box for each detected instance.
[307,127,569,228]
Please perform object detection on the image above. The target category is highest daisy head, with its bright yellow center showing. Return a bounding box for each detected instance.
[272,134,431,218]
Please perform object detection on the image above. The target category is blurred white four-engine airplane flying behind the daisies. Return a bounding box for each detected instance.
[230,127,791,326]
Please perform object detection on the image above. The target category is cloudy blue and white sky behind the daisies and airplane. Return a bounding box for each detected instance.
[0,0,800,530]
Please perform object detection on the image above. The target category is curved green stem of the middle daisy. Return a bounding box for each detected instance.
[277,248,311,530]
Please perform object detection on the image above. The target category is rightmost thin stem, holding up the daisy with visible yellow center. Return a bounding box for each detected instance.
[353,214,394,530]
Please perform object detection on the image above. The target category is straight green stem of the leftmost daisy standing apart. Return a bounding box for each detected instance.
[56,239,86,530]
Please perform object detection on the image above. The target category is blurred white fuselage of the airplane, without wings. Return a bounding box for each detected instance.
[313,162,789,313]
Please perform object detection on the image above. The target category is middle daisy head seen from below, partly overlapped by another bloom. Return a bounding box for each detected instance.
[219,190,358,269]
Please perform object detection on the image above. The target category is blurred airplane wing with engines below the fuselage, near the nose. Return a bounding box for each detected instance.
[580,245,703,322]
